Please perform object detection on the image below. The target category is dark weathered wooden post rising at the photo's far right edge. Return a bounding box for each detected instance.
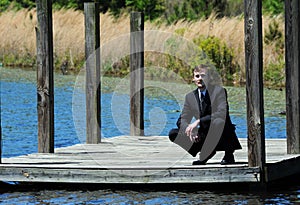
[285,0,300,154]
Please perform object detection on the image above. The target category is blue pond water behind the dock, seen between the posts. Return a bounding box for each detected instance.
[1,68,286,157]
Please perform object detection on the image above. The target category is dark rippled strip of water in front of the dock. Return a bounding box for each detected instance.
[0,187,300,205]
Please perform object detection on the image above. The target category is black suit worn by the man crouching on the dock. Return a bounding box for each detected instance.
[169,85,242,156]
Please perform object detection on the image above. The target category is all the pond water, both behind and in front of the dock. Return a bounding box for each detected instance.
[0,67,300,204]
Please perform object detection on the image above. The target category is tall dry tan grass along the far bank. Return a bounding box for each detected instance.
[0,9,284,86]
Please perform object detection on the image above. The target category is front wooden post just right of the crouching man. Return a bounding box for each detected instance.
[244,0,266,169]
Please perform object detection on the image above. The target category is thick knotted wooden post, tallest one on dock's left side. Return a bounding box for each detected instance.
[36,0,54,153]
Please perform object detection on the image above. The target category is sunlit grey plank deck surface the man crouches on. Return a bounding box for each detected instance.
[3,139,298,168]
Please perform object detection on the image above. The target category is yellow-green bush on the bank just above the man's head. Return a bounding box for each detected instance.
[194,36,238,82]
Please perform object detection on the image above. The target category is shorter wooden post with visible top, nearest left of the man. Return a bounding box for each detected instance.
[130,12,144,136]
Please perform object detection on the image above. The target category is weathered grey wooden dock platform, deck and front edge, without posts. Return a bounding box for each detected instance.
[0,136,300,185]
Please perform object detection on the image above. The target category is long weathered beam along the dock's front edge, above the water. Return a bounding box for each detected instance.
[0,167,260,184]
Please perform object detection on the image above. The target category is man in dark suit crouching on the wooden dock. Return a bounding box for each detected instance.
[169,64,242,165]
